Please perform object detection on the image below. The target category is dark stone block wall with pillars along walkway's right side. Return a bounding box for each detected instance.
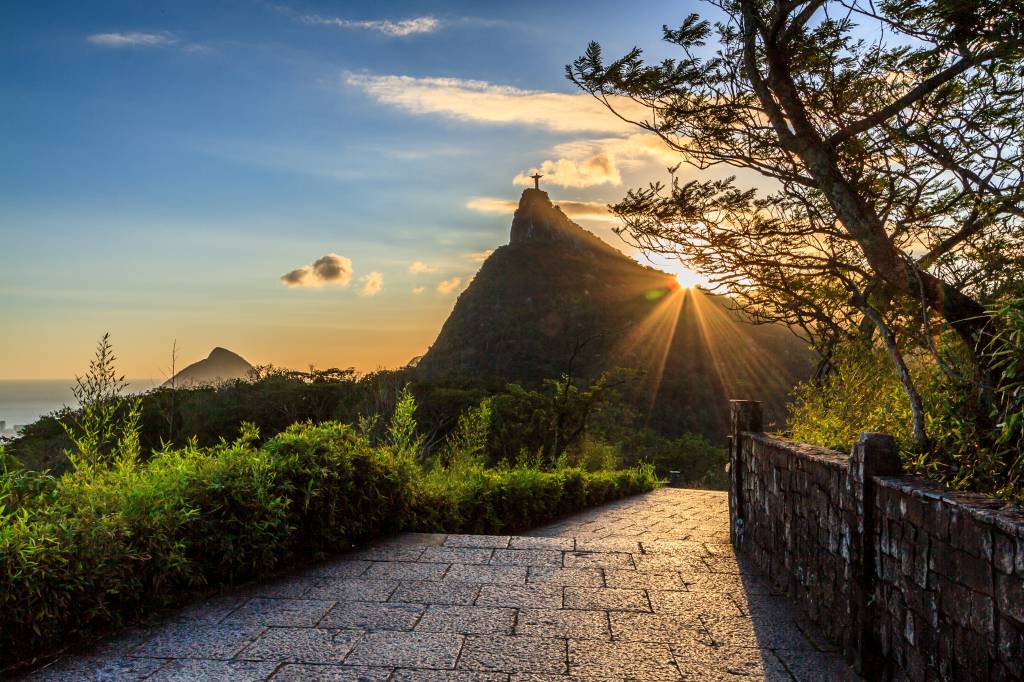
[729,400,1024,680]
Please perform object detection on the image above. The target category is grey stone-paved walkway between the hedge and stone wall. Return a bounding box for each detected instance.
[31,488,846,682]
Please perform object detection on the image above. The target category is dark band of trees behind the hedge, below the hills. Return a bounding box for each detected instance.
[8,356,727,488]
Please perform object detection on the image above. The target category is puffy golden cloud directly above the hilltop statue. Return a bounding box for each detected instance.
[512,133,679,187]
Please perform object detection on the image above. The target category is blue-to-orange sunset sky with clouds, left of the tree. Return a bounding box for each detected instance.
[0,0,709,379]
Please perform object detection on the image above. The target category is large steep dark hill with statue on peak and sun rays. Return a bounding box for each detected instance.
[417,189,812,437]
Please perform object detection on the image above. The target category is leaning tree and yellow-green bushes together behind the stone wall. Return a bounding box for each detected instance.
[566,0,1024,502]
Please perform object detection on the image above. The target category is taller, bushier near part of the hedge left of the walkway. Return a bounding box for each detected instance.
[0,424,414,658]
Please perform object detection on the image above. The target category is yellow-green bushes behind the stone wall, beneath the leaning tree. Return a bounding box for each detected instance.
[788,327,1024,504]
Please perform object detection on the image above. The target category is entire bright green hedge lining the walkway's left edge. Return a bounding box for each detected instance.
[0,376,657,664]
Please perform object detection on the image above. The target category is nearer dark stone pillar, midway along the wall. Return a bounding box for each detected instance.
[847,433,903,680]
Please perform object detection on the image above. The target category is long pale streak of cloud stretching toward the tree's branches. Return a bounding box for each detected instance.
[344,74,645,134]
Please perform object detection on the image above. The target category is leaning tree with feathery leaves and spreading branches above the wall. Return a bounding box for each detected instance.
[566,0,1024,450]
